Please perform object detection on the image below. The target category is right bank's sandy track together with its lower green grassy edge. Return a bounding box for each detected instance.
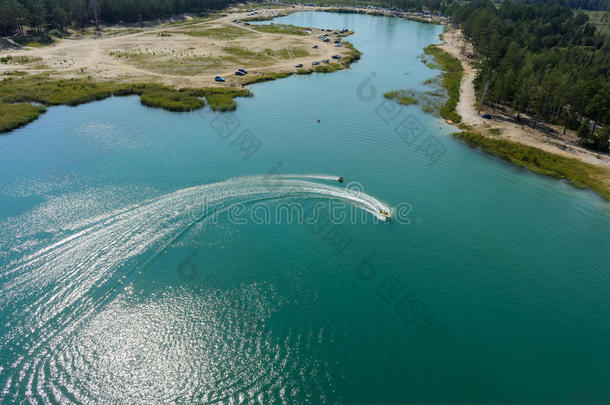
[437,27,610,202]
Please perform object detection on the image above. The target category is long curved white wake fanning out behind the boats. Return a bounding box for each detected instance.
[0,174,390,402]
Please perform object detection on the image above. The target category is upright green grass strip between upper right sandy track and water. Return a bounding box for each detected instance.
[424,45,464,124]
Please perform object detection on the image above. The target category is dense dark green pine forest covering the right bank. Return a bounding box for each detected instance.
[446,0,610,150]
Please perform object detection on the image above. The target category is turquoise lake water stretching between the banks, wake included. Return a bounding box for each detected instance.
[0,13,610,404]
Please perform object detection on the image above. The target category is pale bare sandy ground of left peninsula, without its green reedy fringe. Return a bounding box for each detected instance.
[0,8,347,88]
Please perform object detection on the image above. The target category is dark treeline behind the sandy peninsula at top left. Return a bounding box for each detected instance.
[0,0,229,35]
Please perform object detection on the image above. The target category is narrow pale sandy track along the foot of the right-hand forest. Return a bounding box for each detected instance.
[441,27,610,169]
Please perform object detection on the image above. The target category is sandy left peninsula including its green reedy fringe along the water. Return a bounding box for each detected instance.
[0,7,360,133]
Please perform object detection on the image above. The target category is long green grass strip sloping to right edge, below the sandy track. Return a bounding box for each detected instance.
[453,131,610,202]
